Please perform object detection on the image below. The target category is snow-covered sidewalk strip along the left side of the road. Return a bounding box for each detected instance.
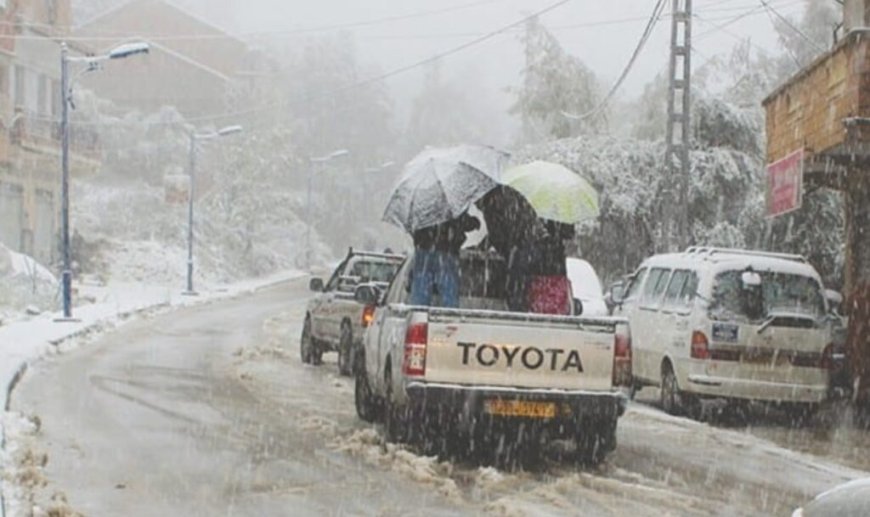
[0,271,303,515]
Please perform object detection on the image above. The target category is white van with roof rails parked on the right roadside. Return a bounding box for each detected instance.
[614,247,832,414]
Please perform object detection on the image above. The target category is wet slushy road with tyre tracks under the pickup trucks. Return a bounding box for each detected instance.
[12,280,863,515]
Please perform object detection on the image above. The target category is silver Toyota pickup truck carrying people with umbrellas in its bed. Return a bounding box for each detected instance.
[354,250,631,464]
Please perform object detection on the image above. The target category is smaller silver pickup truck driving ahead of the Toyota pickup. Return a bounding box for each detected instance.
[299,249,405,375]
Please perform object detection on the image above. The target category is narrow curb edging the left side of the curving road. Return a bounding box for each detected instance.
[0,272,307,517]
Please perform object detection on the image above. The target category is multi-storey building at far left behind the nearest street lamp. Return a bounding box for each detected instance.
[0,0,100,264]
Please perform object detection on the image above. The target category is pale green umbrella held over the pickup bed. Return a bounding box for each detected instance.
[502,161,598,224]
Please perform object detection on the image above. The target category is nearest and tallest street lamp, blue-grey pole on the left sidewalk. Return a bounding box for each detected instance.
[60,42,149,321]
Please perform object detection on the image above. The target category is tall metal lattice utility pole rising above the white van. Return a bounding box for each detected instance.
[662,0,692,251]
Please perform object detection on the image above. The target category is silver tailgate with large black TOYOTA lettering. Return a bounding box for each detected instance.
[425,310,617,391]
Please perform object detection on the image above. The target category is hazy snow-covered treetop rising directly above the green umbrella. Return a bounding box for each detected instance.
[510,18,606,143]
